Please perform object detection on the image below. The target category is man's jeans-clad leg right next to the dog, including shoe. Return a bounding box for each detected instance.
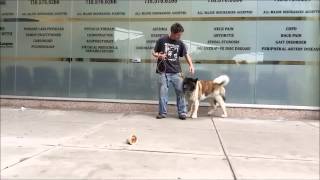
[171,74,187,119]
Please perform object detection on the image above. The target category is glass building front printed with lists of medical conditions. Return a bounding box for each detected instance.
[0,0,320,106]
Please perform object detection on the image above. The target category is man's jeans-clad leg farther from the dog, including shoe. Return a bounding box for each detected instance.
[157,73,169,118]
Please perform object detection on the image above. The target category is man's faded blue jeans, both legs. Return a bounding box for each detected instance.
[158,73,187,115]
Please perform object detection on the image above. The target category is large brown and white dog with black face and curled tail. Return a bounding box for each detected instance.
[183,75,230,118]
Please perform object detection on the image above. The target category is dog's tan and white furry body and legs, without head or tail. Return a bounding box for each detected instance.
[186,80,228,118]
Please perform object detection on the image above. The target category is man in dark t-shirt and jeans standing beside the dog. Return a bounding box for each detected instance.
[152,23,194,120]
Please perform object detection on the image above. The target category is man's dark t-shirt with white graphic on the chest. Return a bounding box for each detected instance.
[154,36,187,73]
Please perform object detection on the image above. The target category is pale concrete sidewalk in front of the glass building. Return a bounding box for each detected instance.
[1,107,319,180]
